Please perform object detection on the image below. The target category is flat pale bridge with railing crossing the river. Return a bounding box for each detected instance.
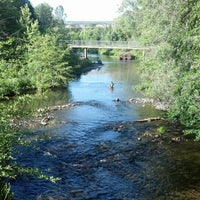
[68,40,150,58]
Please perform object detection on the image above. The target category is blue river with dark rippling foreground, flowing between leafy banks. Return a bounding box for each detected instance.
[12,58,200,200]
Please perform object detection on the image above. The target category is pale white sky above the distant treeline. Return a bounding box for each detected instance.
[30,0,122,21]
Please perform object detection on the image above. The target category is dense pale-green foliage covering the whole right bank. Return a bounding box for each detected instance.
[118,0,200,140]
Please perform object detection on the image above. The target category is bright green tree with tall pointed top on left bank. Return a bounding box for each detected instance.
[21,4,72,91]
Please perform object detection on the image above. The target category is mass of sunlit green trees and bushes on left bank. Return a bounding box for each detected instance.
[0,4,78,98]
